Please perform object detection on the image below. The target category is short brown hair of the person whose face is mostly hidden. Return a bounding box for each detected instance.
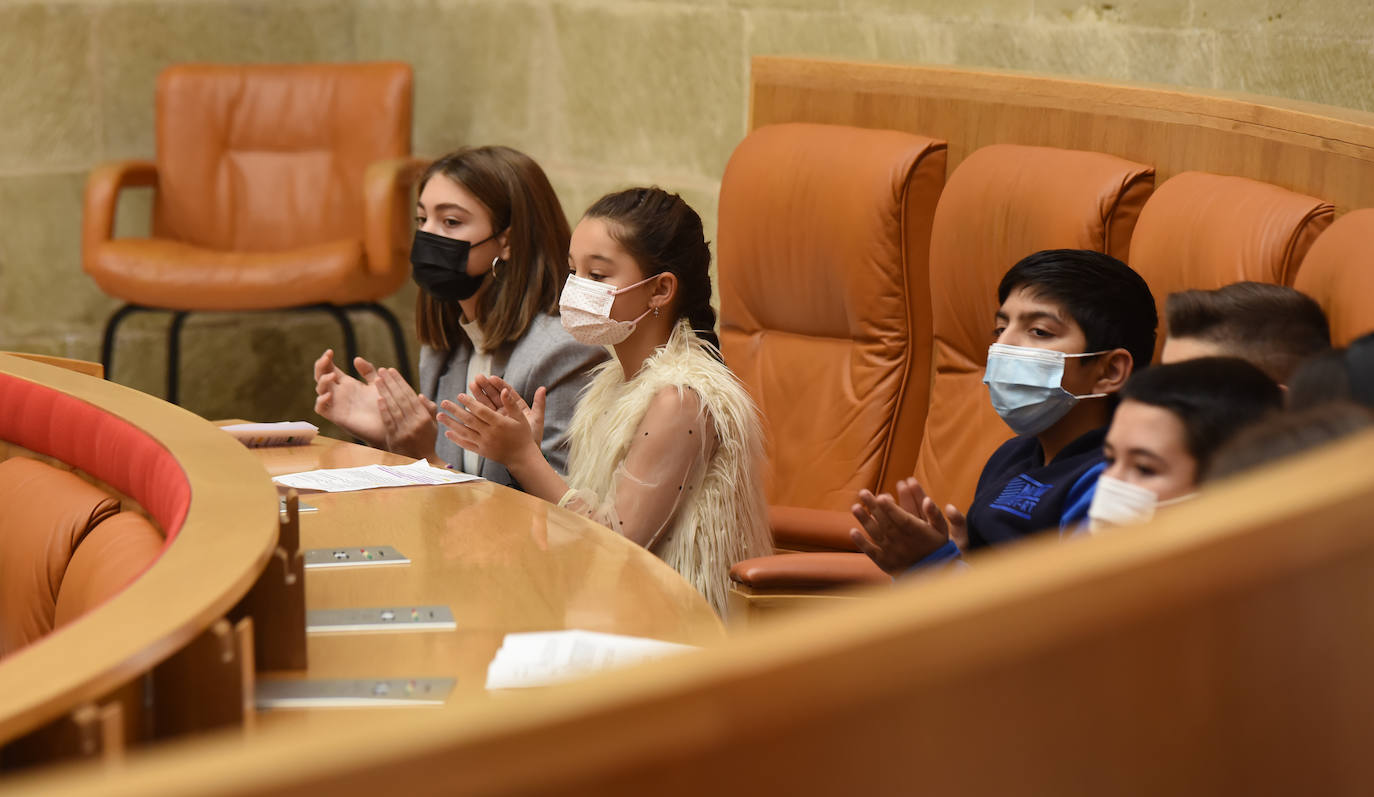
[1164,282,1331,383]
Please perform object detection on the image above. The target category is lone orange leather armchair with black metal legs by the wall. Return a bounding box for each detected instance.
[81,63,415,403]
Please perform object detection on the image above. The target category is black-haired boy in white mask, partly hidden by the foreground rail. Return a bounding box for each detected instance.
[1088,357,1283,532]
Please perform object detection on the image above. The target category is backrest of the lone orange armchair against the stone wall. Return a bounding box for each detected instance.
[154,63,411,251]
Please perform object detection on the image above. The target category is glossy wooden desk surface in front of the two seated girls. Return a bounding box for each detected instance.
[256,437,724,726]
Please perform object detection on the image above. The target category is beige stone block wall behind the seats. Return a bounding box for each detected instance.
[0,0,1374,419]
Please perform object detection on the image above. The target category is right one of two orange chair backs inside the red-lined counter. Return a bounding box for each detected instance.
[52,511,162,629]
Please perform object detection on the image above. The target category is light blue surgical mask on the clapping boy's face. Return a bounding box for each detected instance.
[982,344,1106,434]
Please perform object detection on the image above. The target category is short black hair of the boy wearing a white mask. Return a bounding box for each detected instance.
[1121,357,1283,474]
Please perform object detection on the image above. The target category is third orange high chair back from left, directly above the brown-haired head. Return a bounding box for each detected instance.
[1127,172,1336,353]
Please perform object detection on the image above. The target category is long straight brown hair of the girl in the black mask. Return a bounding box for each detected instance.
[415,147,572,352]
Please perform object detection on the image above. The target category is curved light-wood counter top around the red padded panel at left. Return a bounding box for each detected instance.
[0,356,278,742]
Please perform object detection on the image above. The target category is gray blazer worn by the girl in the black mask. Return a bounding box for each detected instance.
[420,313,610,488]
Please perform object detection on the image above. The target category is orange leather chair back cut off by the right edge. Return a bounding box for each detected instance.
[1293,207,1374,346]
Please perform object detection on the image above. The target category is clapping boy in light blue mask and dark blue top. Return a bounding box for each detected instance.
[851,249,1158,574]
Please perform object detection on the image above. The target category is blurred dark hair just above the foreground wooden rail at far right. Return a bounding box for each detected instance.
[1202,401,1374,481]
